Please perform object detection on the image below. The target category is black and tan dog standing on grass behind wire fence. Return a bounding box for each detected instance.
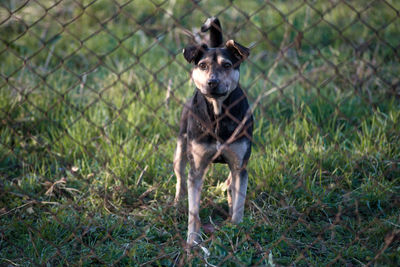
[174,17,253,246]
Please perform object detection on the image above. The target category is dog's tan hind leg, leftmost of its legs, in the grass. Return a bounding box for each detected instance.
[174,136,188,205]
